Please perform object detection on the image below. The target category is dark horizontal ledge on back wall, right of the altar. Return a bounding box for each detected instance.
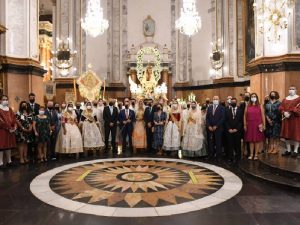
[173,80,250,91]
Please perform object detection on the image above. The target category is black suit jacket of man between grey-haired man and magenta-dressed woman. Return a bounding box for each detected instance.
[225,107,244,131]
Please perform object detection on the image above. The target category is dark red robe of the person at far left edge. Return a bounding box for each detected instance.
[0,104,17,151]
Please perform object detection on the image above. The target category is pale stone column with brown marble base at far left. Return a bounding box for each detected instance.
[0,0,45,109]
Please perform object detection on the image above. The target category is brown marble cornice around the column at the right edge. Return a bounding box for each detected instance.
[246,54,300,75]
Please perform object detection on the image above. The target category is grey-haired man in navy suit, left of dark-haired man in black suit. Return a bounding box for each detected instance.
[206,96,225,160]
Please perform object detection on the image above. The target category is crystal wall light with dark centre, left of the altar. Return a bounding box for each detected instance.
[50,38,77,76]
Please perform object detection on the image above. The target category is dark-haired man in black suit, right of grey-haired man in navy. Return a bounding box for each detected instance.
[225,98,244,164]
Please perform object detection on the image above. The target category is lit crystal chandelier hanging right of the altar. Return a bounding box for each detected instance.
[175,0,201,37]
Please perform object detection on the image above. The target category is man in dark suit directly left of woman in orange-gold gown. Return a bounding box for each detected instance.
[119,101,136,150]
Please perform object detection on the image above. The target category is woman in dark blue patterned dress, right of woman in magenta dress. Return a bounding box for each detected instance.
[265,91,282,154]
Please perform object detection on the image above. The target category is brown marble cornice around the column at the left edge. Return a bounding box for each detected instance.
[0,56,47,77]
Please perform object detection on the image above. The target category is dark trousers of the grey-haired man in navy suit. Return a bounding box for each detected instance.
[208,129,223,159]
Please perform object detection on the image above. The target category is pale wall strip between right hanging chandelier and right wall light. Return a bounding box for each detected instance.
[192,0,212,84]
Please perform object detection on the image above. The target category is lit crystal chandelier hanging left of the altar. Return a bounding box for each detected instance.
[81,0,109,37]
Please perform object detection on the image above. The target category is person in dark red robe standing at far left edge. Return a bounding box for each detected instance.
[0,95,17,168]
